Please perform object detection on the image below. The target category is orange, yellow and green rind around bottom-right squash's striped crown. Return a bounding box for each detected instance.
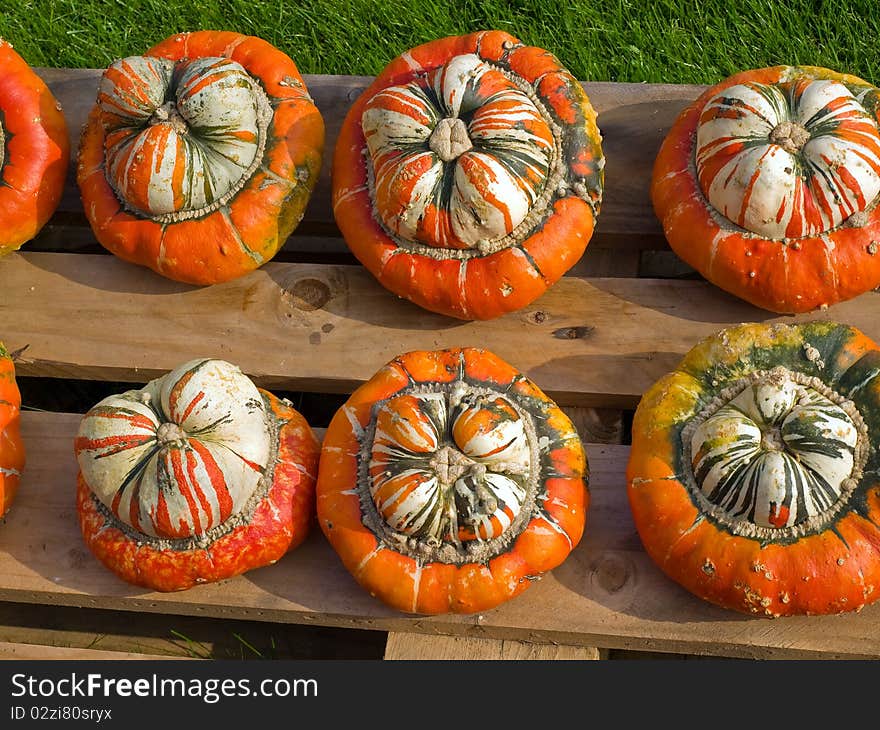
[627,322,880,617]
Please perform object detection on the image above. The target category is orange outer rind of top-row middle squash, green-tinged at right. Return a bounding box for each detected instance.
[333,31,604,319]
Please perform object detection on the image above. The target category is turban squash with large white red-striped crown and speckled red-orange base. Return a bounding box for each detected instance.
[74,360,319,591]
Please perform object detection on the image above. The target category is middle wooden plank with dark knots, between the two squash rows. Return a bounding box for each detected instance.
[8,253,880,408]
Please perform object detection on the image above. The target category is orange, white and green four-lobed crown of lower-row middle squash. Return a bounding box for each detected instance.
[369,391,531,544]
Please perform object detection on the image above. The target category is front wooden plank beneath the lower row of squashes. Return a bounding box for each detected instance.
[0,413,880,659]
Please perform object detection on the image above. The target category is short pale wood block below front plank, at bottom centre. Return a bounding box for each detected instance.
[385,632,605,661]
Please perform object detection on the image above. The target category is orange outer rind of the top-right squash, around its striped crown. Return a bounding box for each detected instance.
[651,66,880,313]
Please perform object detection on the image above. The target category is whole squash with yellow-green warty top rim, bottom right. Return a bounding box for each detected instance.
[627,322,880,616]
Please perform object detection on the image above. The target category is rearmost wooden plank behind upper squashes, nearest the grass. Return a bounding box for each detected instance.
[36,68,704,249]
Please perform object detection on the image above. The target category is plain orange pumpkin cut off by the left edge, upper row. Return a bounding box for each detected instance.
[0,39,70,256]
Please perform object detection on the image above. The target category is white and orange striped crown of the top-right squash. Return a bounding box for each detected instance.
[696,77,880,239]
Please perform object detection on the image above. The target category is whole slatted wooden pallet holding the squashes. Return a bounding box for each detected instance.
[0,69,880,658]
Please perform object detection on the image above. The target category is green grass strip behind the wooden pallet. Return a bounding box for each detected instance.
[0,0,880,83]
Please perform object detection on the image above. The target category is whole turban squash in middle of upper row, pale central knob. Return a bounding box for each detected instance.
[333,31,604,319]
